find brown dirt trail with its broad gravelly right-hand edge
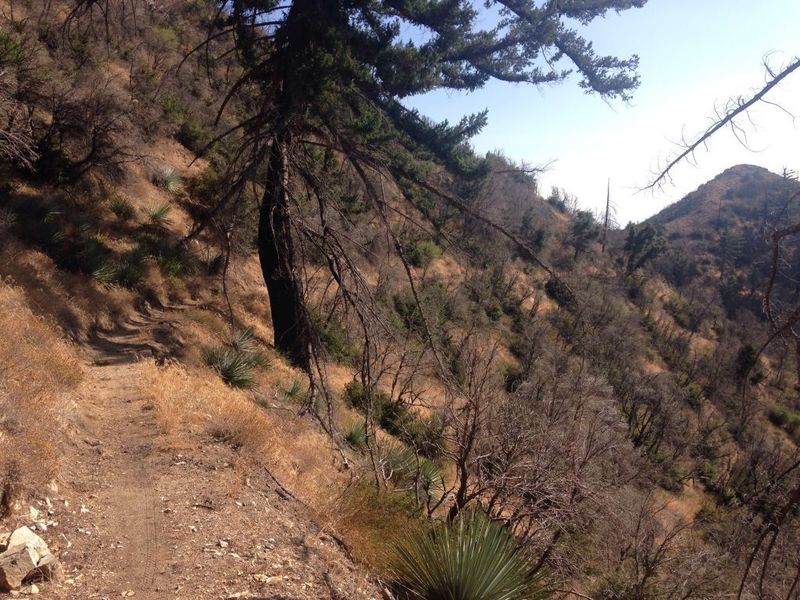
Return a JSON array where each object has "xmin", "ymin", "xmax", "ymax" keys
[{"xmin": 30, "ymin": 311, "xmax": 381, "ymax": 600}]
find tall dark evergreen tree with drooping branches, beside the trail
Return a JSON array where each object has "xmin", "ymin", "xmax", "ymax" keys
[{"xmin": 195, "ymin": 0, "xmax": 646, "ymax": 367}]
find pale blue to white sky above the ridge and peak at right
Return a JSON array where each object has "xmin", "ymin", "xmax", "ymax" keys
[{"xmin": 409, "ymin": 0, "xmax": 800, "ymax": 226}]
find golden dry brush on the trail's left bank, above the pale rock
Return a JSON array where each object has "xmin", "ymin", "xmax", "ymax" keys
[{"xmin": 0, "ymin": 283, "xmax": 81, "ymax": 517}]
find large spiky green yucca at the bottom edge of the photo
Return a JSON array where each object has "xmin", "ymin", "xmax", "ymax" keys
[{"xmin": 390, "ymin": 510, "xmax": 549, "ymax": 600}]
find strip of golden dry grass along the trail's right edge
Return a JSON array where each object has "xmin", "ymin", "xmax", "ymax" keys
[{"xmin": 142, "ymin": 361, "xmax": 428, "ymax": 571}]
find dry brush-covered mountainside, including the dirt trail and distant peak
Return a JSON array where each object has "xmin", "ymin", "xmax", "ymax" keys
[{"xmin": 0, "ymin": 0, "xmax": 800, "ymax": 600}]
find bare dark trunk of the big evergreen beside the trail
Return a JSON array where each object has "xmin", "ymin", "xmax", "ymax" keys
[{"xmin": 258, "ymin": 138, "xmax": 311, "ymax": 370}]
